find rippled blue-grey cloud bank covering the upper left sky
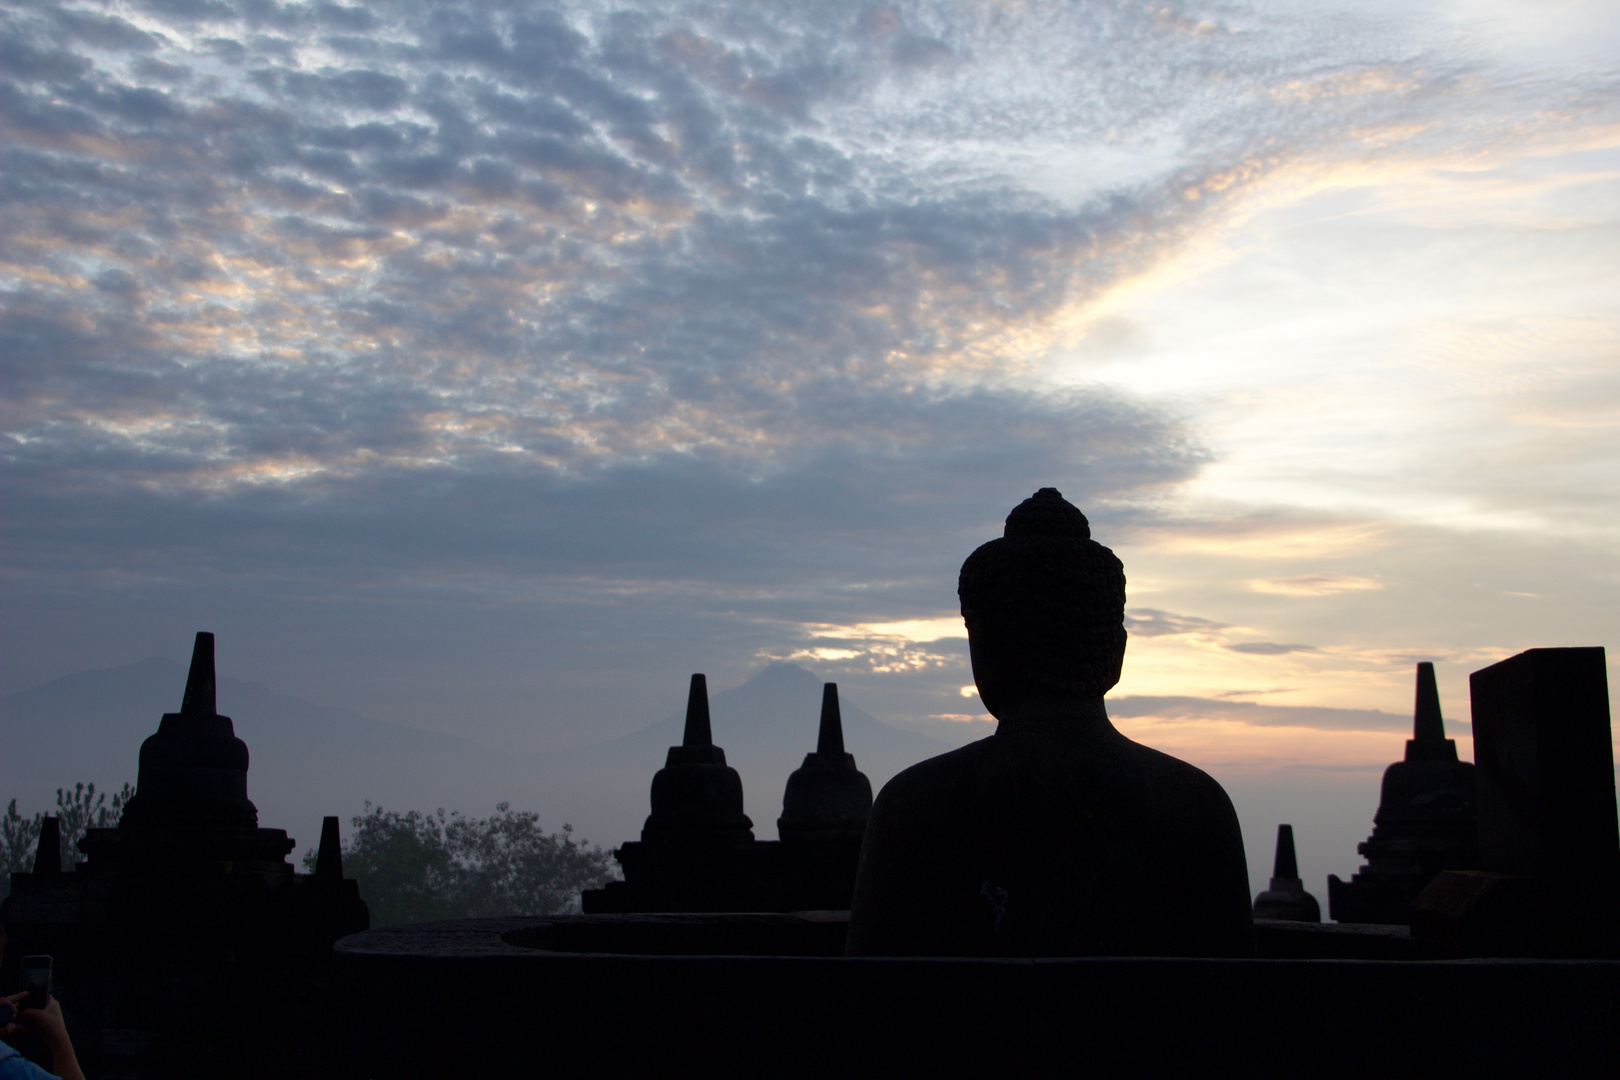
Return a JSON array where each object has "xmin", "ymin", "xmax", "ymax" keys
[{"xmin": 0, "ymin": 0, "xmax": 1496, "ymax": 621}]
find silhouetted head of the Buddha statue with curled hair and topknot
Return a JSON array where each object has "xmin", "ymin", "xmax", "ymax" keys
[{"xmin": 956, "ymin": 487, "xmax": 1126, "ymax": 708}]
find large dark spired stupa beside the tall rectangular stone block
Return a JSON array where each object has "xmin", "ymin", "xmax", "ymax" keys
[{"xmin": 1327, "ymin": 661, "xmax": 1479, "ymax": 925}]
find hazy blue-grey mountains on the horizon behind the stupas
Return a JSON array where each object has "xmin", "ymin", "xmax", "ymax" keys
[{"xmin": 0, "ymin": 657, "xmax": 949, "ymax": 852}]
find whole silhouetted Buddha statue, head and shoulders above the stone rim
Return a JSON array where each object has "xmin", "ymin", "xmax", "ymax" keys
[{"xmin": 847, "ymin": 487, "xmax": 1254, "ymax": 957}]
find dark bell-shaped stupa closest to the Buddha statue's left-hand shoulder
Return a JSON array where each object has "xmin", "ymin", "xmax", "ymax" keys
[{"xmin": 776, "ymin": 683, "xmax": 872, "ymax": 910}]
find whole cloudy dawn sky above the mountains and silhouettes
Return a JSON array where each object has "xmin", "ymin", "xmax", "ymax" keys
[{"xmin": 0, "ymin": 0, "xmax": 1620, "ymax": 873}]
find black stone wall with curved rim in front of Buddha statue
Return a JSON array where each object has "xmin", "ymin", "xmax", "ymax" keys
[{"xmin": 334, "ymin": 916, "xmax": 1620, "ymax": 1078}]
